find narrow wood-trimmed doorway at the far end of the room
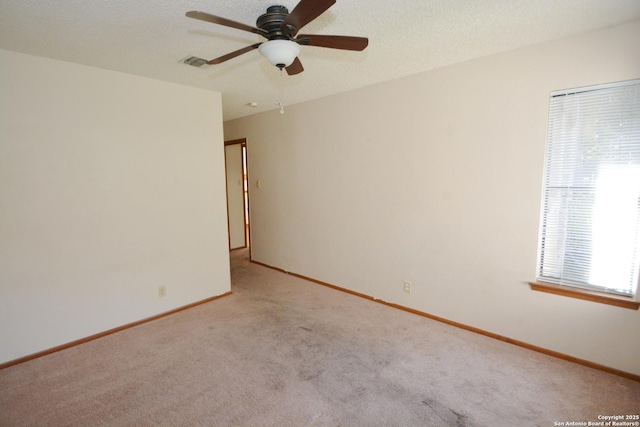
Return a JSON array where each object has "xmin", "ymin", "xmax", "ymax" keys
[{"xmin": 224, "ymin": 138, "xmax": 251, "ymax": 250}]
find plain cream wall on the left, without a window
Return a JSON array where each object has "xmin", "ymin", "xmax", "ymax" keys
[{"xmin": 0, "ymin": 51, "xmax": 230, "ymax": 362}]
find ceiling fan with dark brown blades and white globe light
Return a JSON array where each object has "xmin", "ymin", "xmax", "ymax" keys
[{"xmin": 187, "ymin": 0, "xmax": 369, "ymax": 75}]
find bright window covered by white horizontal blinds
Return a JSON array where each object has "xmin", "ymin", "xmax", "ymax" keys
[{"xmin": 538, "ymin": 80, "xmax": 640, "ymax": 296}]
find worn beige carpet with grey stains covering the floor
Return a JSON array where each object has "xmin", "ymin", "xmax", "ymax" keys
[{"xmin": 0, "ymin": 251, "xmax": 640, "ymax": 426}]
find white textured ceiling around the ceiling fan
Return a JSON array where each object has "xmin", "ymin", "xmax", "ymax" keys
[{"xmin": 0, "ymin": 0, "xmax": 640, "ymax": 120}]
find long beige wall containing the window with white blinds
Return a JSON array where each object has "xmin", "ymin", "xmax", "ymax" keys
[{"xmin": 225, "ymin": 22, "xmax": 640, "ymax": 374}]
